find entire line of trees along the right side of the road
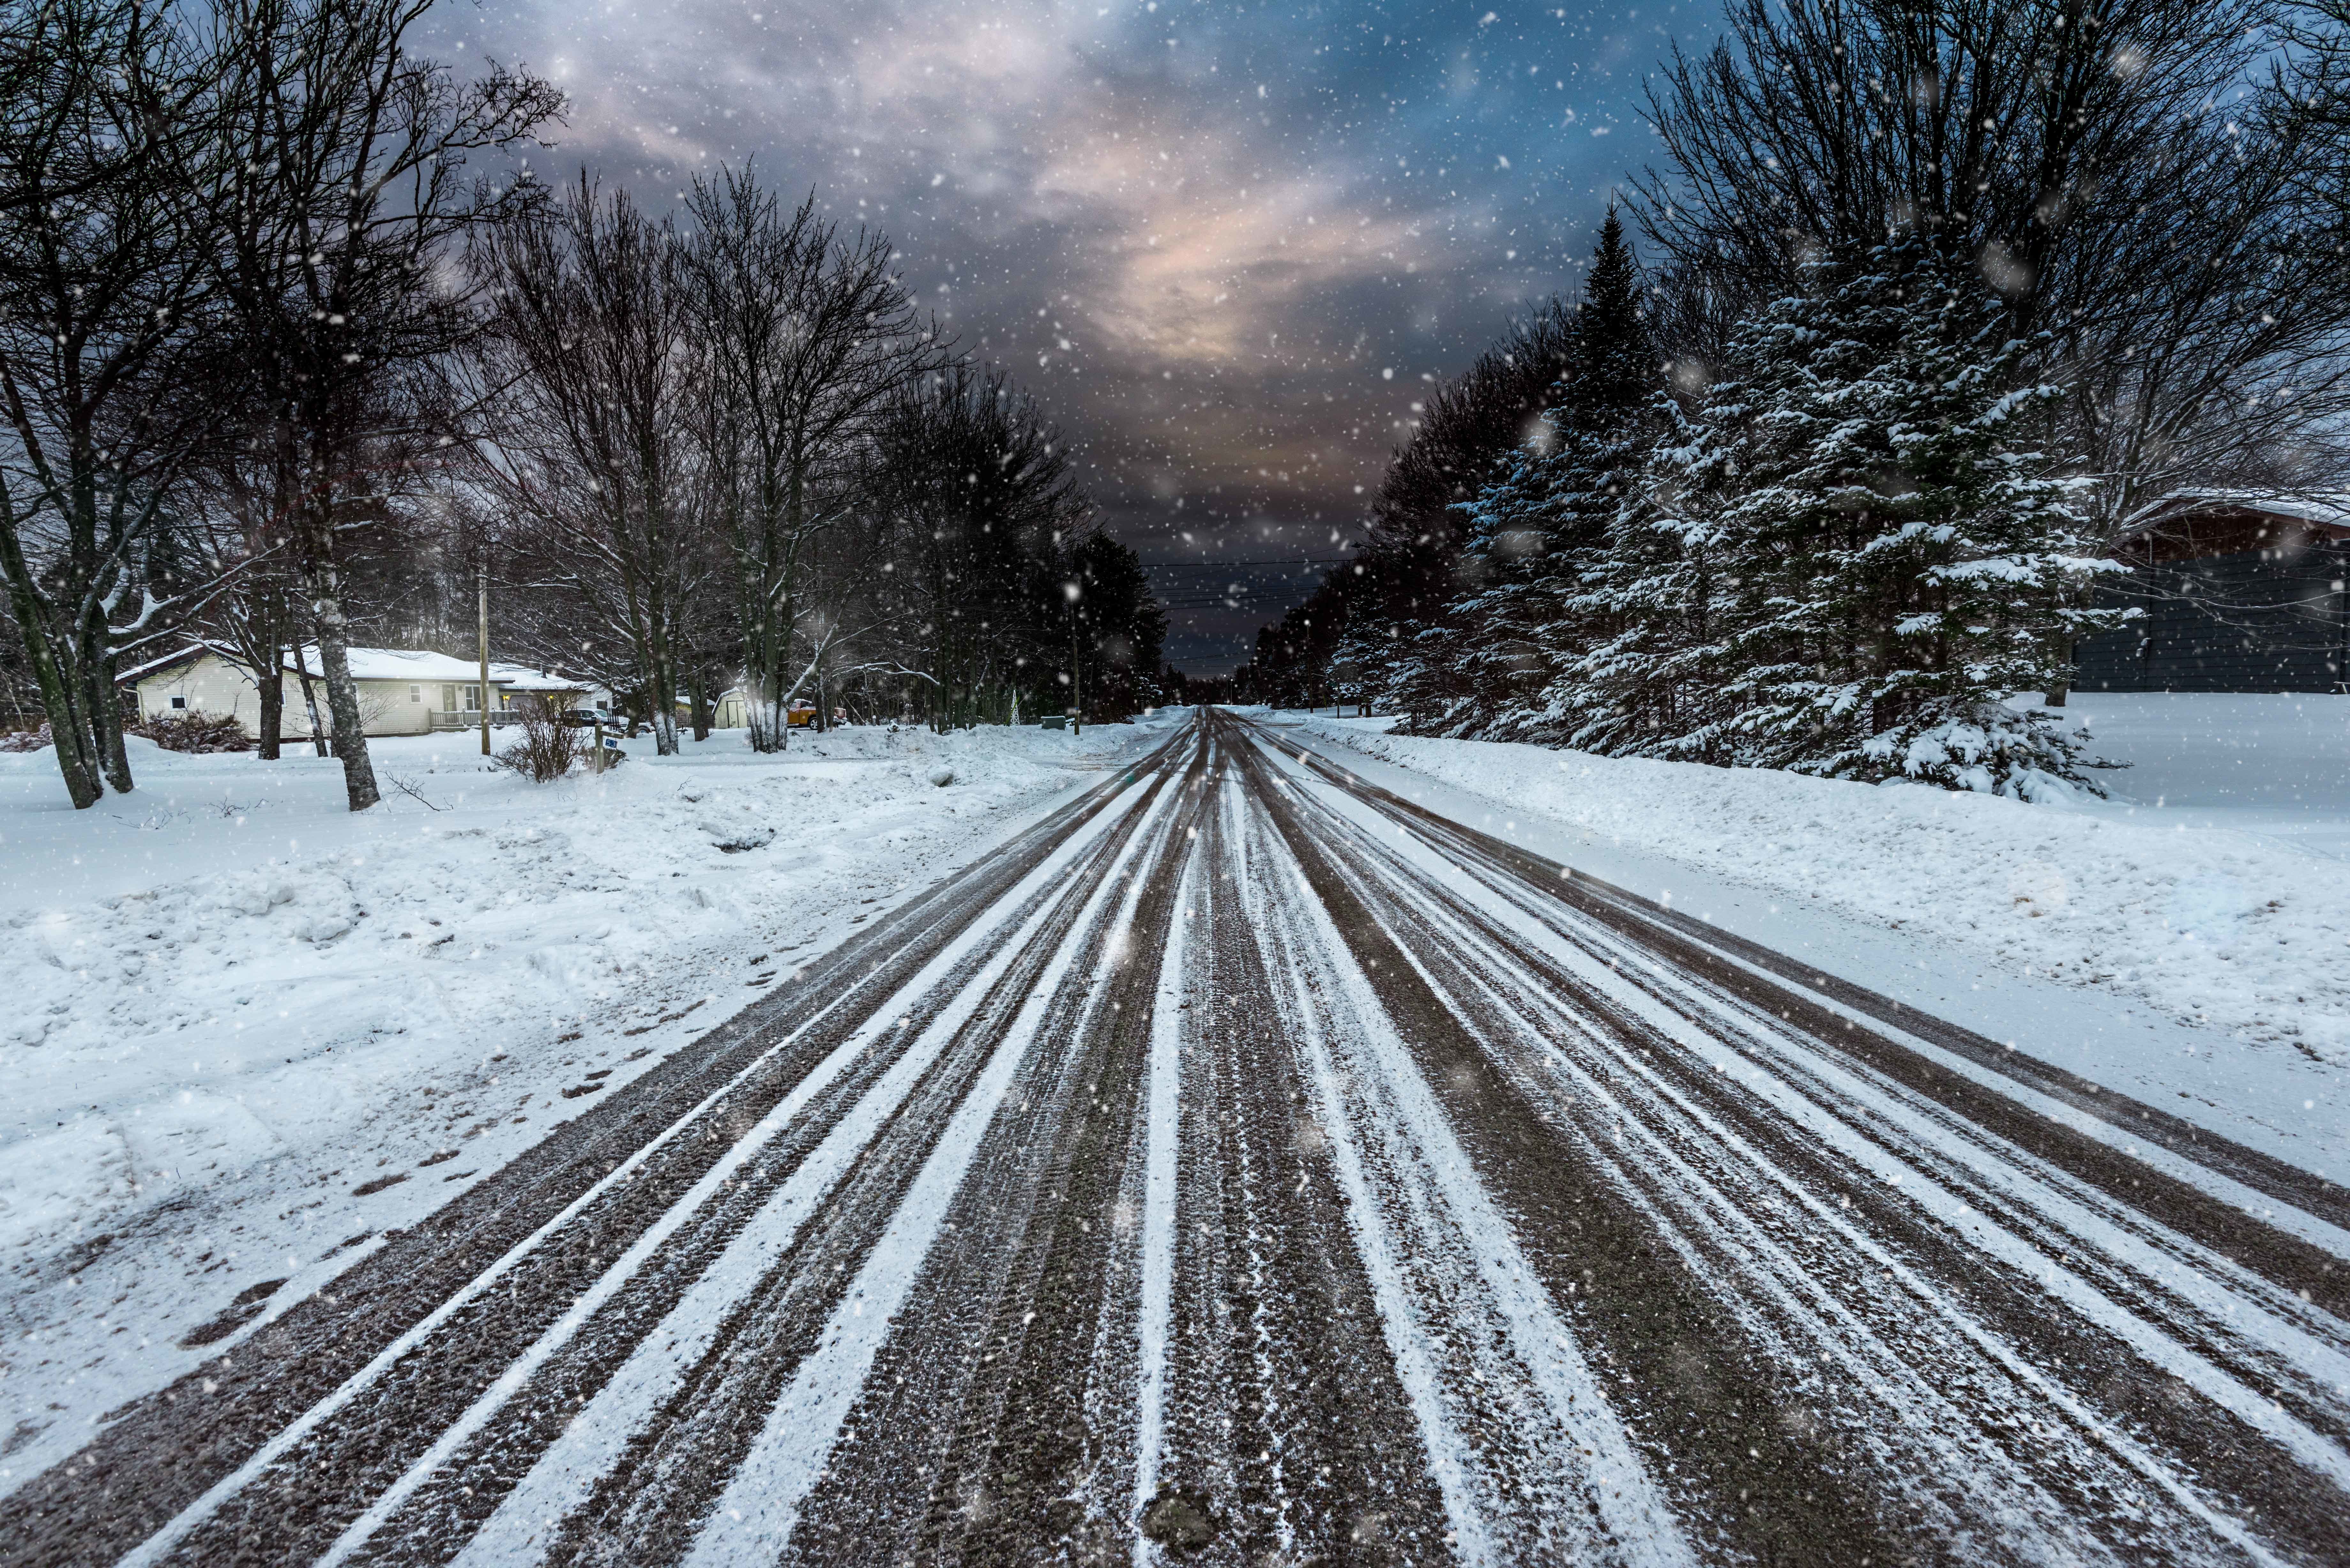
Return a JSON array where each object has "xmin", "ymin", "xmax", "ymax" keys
[{"xmin": 1243, "ymin": 0, "xmax": 2350, "ymax": 795}]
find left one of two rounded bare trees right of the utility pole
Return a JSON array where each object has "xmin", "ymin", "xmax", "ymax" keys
[{"xmin": 472, "ymin": 174, "xmax": 705, "ymax": 755}]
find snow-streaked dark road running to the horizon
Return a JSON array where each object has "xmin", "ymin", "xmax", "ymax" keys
[{"xmin": 0, "ymin": 715, "xmax": 2350, "ymax": 1566}]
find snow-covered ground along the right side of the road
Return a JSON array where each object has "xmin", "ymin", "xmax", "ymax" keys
[{"xmin": 1307, "ymin": 693, "xmax": 2350, "ymax": 1079}]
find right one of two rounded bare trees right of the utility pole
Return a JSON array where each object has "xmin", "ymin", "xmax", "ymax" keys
[{"xmin": 686, "ymin": 169, "xmax": 938, "ymax": 750}]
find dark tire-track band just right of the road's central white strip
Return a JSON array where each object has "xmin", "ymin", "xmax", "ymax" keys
[{"xmin": 1135, "ymin": 752, "xmax": 1448, "ymax": 1566}]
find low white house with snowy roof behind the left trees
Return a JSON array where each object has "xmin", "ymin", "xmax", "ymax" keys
[{"xmin": 120, "ymin": 642, "xmax": 611, "ymax": 741}]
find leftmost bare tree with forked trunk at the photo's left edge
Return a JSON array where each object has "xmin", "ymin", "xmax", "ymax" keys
[{"xmin": 0, "ymin": 0, "xmax": 214, "ymax": 809}]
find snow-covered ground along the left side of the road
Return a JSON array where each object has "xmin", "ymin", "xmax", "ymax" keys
[{"xmin": 0, "ymin": 715, "xmax": 1175, "ymax": 1490}]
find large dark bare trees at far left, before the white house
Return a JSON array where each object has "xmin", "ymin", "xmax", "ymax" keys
[{"xmin": 0, "ymin": 0, "xmax": 559, "ymax": 806}]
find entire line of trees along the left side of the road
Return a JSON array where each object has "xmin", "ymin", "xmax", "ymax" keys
[{"xmin": 0, "ymin": 0, "xmax": 1163, "ymax": 809}]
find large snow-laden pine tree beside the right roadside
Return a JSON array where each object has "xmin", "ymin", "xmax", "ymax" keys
[{"xmin": 1577, "ymin": 237, "xmax": 2124, "ymax": 799}]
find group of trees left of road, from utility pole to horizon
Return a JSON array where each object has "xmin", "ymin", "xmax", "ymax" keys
[{"xmin": 456, "ymin": 172, "xmax": 1166, "ymax": 750}]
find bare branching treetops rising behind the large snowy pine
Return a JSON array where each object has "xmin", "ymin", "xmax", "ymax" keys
[{"xmin": 1640, "ymin": 0, "xmax": 2350, "ymax": 531}]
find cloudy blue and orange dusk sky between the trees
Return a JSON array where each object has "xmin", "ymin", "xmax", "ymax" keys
[{"xmin": 425, "ymin": 0, "xmax": 1716, "ymax": 672}]
